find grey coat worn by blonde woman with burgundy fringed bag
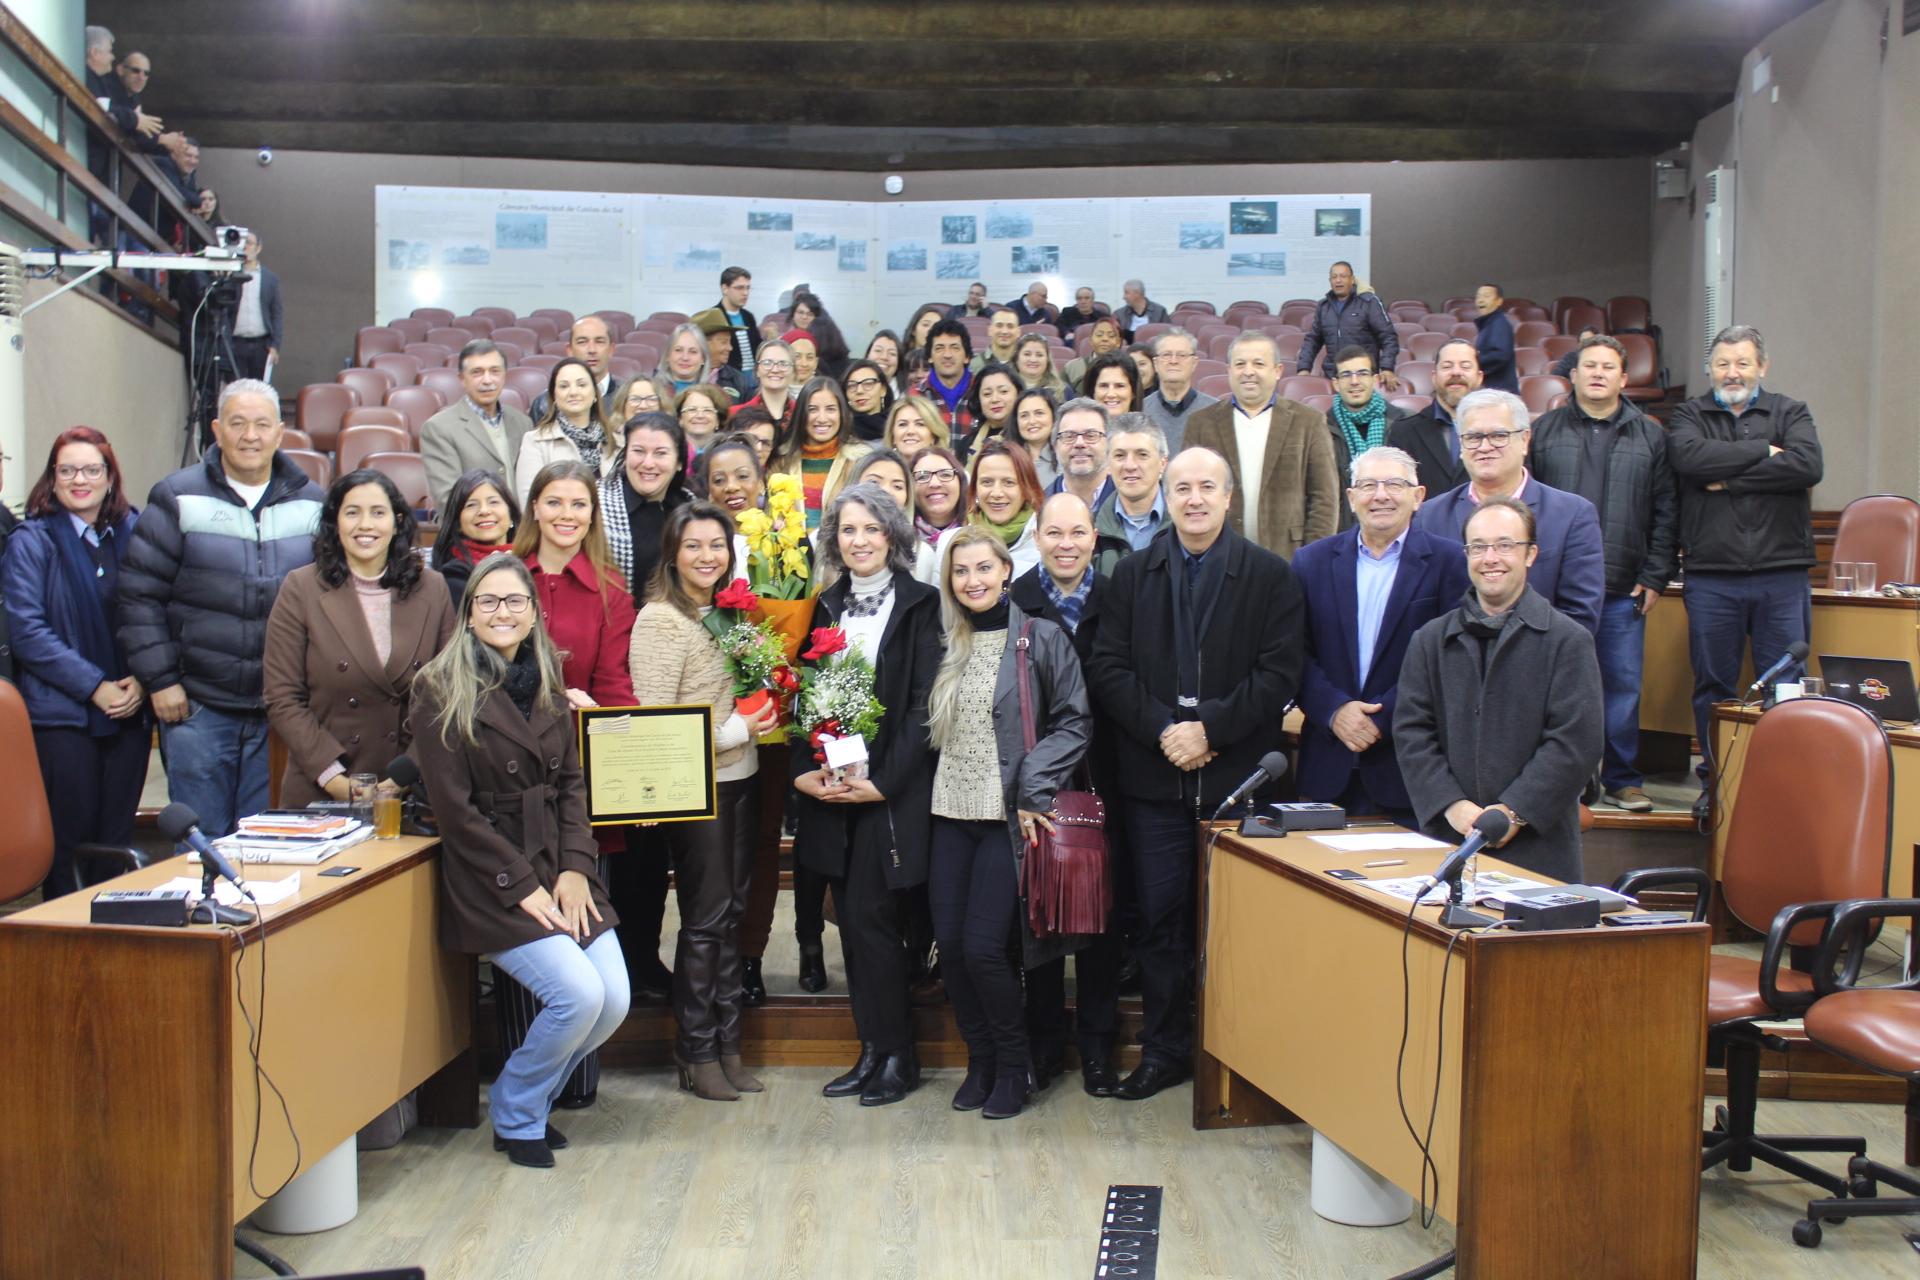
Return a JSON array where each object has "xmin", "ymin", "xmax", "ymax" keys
[{"xmin": 993, "ymin": 603, "xmax": 1092, "ymax": 969}]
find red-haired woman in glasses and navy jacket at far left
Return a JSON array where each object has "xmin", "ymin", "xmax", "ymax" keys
[{"xmin": 0, "ymin": 426, "xmax": 150, "ymax": 898}]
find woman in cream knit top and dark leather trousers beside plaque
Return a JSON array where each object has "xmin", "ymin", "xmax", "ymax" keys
[{"xmin": 630, "ymin": 501, "xmax": 780, "ymax": 1102}]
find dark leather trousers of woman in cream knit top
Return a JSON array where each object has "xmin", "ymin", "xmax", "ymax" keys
[{"xmin": 668, "ymin": 777, "xmax": 760, "ymax": 1063}]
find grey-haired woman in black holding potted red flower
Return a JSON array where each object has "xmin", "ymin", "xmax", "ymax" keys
[{"xmin": 789, "ymin": 484, "xmax": 941, "ymax": 1107}]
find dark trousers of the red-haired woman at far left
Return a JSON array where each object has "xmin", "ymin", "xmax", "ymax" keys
[{"xmin": 33, "ymin": 716, "xmax": 154, "ymax": 898}]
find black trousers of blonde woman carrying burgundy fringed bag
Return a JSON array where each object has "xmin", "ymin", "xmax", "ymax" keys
[{"xmin": 927, "ymin": 818, "xmax": 1031, "ymax": 1071}]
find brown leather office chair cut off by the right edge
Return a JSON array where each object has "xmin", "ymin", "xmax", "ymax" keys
[{"xmin": 1793, "ymin": 898, "xmax": 1920, "ymax": 1249}]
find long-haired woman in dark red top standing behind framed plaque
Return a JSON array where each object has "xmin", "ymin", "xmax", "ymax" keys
[{"xmin": 514, "ymin": 462, "xmax": 641, "ymax": 1107}]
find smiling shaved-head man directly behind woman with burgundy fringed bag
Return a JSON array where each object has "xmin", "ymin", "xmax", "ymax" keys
[{"xmin": 1010, "ymin": 493, "xmax": 1133, "ymax": 1098}]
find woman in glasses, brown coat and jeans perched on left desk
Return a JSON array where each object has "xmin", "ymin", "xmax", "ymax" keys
[{"xmin": 413, "ymin": 555, "xmax": 628, "ymax": 1169}]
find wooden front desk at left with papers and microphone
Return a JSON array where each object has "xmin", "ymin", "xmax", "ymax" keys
[{"xmin": 0, "ymin": 839, "xmax": 478, "ymax": 1280}]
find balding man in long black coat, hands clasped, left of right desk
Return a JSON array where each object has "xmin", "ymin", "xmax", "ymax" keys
[{"xmin": 1087, "ymin": 449, "xmax": 1306, "ymax": 1100}]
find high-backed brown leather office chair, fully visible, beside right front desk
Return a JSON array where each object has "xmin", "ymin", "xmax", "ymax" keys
[{"xmin": 1615, "ymin": 699, "xmax": 1893, "ymax": 1196}]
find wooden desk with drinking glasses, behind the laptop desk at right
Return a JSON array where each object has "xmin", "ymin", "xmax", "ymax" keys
[{"xmin": 1640, "ymin": 587, "xmax": 1920, "ymax": 737}]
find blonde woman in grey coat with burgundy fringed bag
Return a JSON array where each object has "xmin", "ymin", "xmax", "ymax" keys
[{"xmin": 927, "ymin": 528, "xmax": 1092, "ymax": 1121}]
